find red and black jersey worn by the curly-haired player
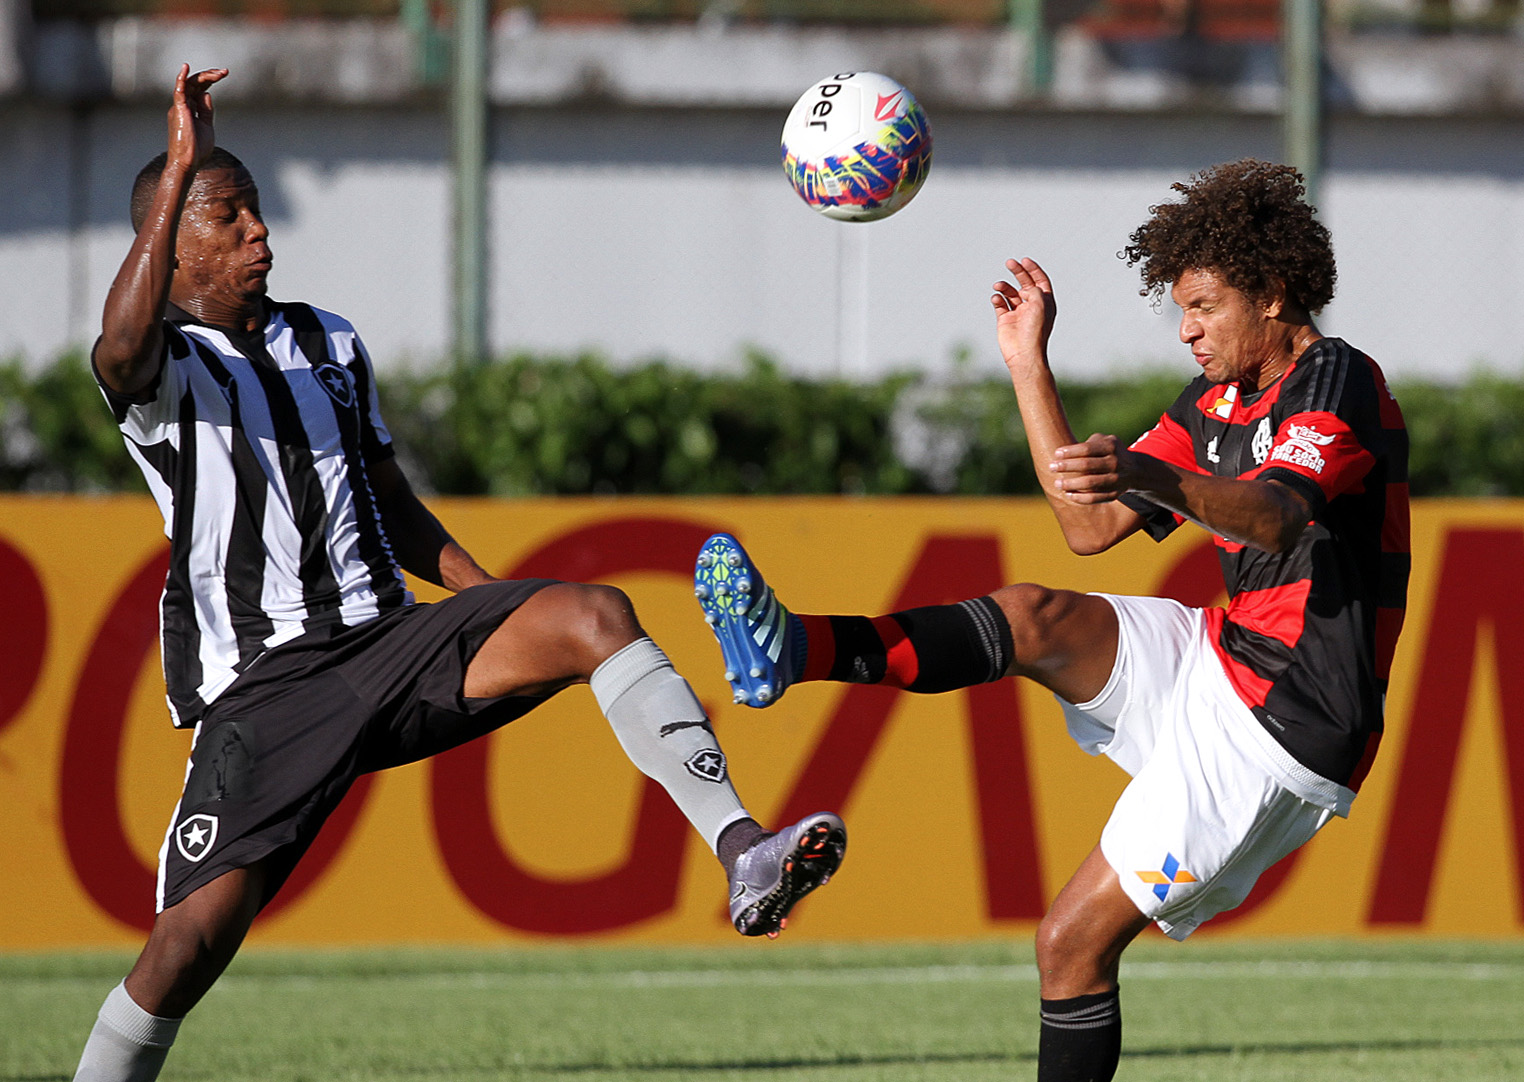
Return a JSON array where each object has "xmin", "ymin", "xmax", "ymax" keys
[{"xmin": 1123, "ymin": 338, "xmax": 1410, "ymax": 789}]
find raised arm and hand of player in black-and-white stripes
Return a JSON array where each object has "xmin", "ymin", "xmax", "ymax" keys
[{"xmin": 94, "ymin": 64, "xmax": 227, "ymax": 395}]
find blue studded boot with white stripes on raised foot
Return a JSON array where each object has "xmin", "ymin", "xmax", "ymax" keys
[{"xmin": 693, "ymin": 533, "xmax": 805, "ymax": 707}]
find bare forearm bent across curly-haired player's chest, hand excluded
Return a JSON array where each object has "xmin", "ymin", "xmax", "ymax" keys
[{"xmin": 1129, "ymin": 456, "xmax": 1311, "ymax": 553}]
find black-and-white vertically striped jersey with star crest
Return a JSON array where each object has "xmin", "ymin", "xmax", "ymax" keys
[{"xmin": 102, "ymin": 302, "xmax": 413, "ymax": 728}]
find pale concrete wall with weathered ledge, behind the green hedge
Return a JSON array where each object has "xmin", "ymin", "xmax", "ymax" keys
[{"xmin": 0, "ymin": 19, "xmax": 1524, "ymax": 376}]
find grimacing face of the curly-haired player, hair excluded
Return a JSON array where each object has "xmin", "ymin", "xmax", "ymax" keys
[{"xmin": 1169, "ymin": 270, "xmax": 1283, "ymax": 390}]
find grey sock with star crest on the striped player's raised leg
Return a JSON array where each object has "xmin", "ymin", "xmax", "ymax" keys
[{"xmin": 588, "ymin": 639, "xmax": 747, "ymax": 849}]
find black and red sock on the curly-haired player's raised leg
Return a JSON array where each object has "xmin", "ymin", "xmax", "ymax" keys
[{"xmin": 796, "ymin": 597, "xmax": 1012, "ymax": 695}]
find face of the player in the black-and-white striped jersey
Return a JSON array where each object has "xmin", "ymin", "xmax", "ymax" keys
[{"xmin": 175, "ymin": 169, "xmax": 273, "ymax": 308}]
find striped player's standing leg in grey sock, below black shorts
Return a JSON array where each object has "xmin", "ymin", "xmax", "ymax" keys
[{"xmin": 75, "ymin": 864, "xmax": 265, "ymax": 1082}]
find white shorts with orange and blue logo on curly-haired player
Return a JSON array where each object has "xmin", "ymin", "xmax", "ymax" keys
[{"xmin": 1059, "ymin": 594, "xmax": 1355, "ymax": 939}]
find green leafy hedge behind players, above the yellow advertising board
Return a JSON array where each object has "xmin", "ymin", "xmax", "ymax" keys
[{"xmin": 0, "ymin": 354, "xmax": 1524, "ymax": 495}]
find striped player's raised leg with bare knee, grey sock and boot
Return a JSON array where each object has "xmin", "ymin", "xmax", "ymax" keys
[{"xmin": 465, "ymin": 582, "xmax": 846, "ymax": 936}]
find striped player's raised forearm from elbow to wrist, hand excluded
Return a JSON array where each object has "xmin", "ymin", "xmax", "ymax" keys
[{"xmin": 94, "ymin": 165, "xmax": 194, "ymax": 393}]
